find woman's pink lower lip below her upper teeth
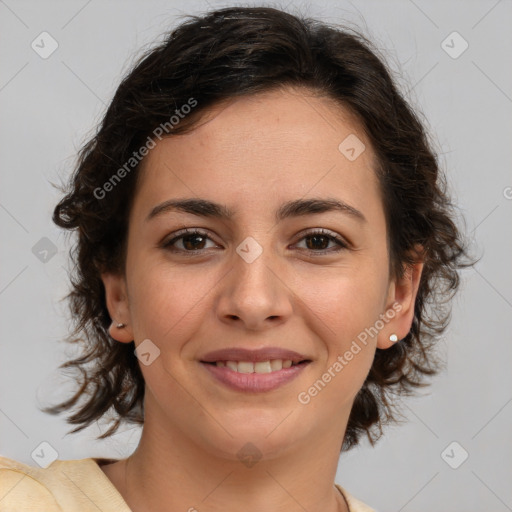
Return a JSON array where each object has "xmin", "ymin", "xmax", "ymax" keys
[{"xmin": 201, "ymin": 363, "xmax": 309, "ymax": 393}]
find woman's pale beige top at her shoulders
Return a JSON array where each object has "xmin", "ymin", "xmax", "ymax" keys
[{"xmin": 0, "ymin": 456, "xmax": 375, "ymax": 512}]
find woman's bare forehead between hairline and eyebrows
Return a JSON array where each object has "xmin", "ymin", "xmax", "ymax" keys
[{"xmin": 137, "ymin": 88, "xmax": 379, "ymax": 222}]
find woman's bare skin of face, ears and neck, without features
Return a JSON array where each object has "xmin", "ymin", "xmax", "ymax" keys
[{"xmin": 102, "ymin": 88, "xmax": 423, "ymax": 512}]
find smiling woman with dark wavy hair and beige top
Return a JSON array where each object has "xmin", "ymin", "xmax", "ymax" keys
[{"xmin": 0, "ymin": 7, "xmax": 469, "ymax": 512}]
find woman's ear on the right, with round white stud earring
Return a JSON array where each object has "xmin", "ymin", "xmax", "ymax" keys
[{"xmin": 377, "ymin": 246, "xmax": 424, "ymax": 349}]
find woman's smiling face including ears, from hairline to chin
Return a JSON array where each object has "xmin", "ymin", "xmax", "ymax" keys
[{"xmin": 103, "ymin": 89, "xmax": 421, "ymax": 460}]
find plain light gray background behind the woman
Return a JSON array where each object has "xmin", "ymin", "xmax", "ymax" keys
[{"xmin": 0, "ymin": 0, "xmax": 512, "ymax": 512}]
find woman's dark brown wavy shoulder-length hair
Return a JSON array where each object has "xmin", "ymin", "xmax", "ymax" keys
[{"xmin": 43, "ymin": 7, "xmax": 472, "ymax": 450}]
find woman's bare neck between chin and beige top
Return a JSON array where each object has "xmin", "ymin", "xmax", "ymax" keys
[{"xmin": 104, "ymin": 394, "xmax": 348, "ymax": 512}]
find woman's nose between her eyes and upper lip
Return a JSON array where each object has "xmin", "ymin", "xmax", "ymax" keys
[{"xmin": 217, "ymin": 240, "xmax": 294, "ymax": 331}]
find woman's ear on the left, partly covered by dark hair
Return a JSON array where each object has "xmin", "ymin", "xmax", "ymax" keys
[{"xmin": 101, "ymin": 273, "xmax": 133, "ymax": 343}]
